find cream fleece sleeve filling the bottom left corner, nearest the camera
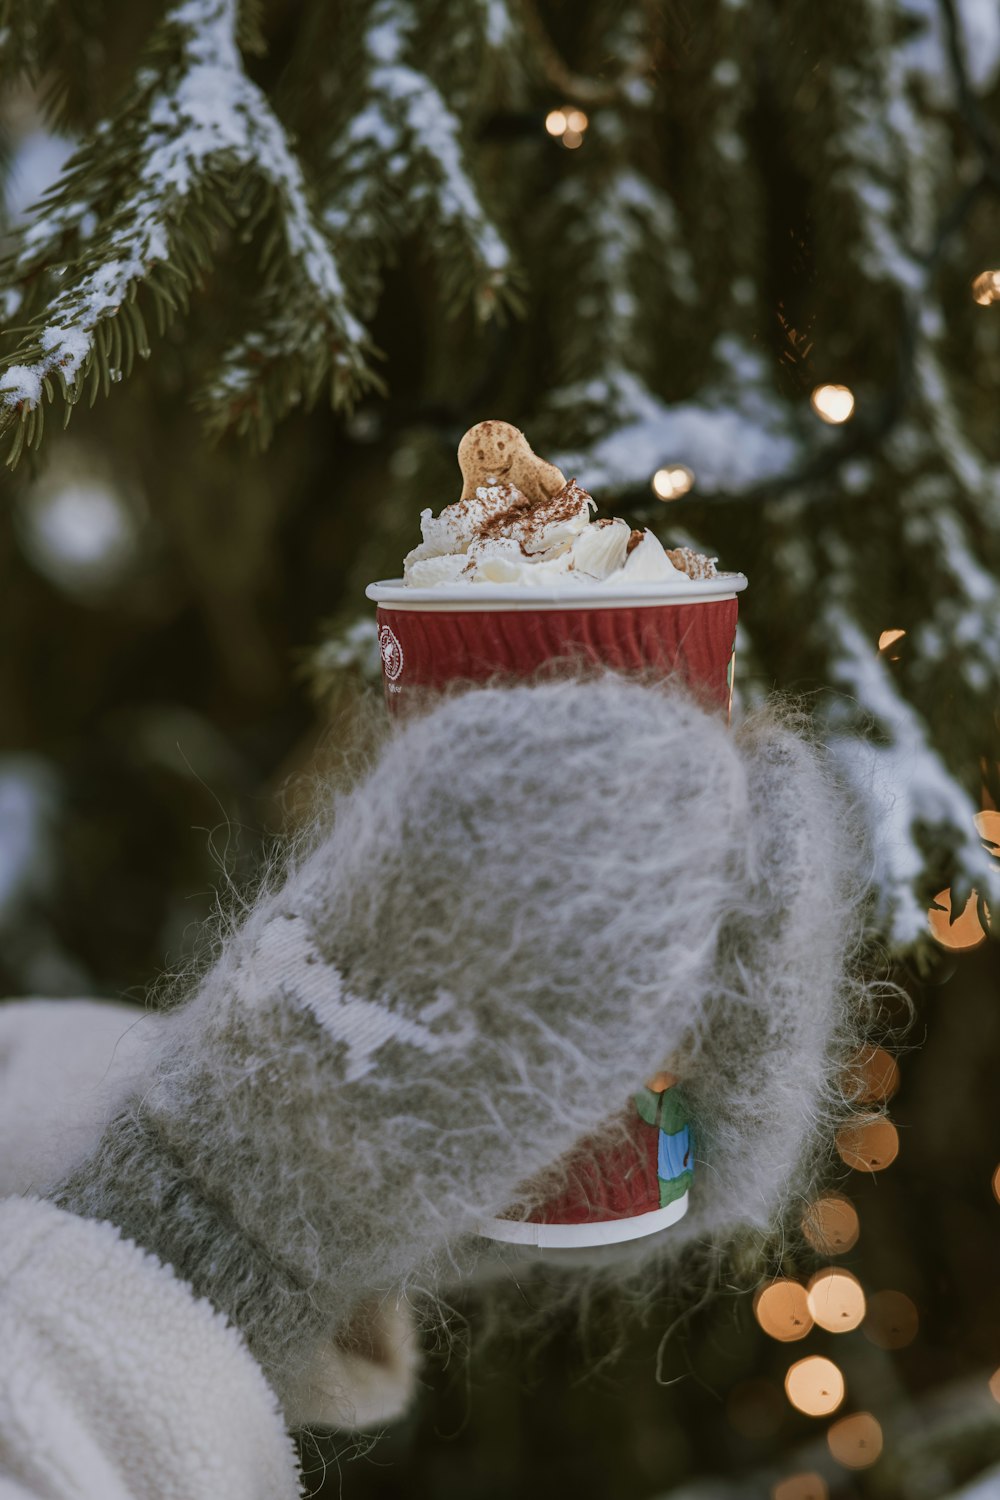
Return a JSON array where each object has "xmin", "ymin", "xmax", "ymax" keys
[{"xmin": 0, "ymin": 1199, "xmax": 301, "ymax": 1500}]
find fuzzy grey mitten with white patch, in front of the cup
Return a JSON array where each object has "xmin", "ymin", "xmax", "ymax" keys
[{"xmin": 52, "ymin": 677, "xmax": 863, "ymax": 1394}]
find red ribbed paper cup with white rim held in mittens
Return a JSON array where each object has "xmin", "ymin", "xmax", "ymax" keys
[{"xmin": 366, "ymin": 573, "xmax": 747, "ymax": 1250}]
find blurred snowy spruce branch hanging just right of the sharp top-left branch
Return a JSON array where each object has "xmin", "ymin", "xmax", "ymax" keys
[{"xmin": 324, "ymin": 0, "xmax": 511, "ymax": 317}]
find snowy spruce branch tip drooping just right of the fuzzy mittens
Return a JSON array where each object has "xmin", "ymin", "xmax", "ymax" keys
[{"xmin": 826, "ymin": 606, "xmax": 997, "ymax": 948}]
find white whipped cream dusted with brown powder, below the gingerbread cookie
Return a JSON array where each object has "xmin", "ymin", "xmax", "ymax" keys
[{"xmin": 403, "ymin": 479, "xmax": 715, "ymax": 588}]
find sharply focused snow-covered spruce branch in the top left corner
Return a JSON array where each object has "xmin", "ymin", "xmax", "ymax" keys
[{"xmin": 0, "ymin": 0, "xmax": 366, "ymax": 458}]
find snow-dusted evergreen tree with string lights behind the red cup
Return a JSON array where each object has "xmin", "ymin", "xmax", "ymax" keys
[{"xmin": 0, "ymin": 0, "xmax": 1000, "ymax": 947}]
